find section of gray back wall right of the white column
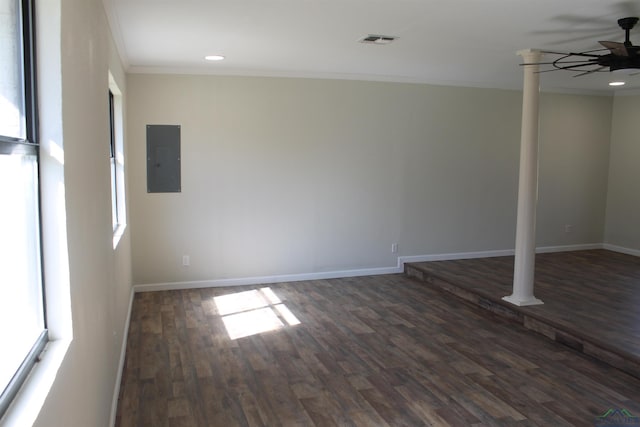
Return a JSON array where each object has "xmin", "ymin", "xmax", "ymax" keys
[{"xmin": 537, "ymin": 94, "xmax": 613, "ymax": 246}]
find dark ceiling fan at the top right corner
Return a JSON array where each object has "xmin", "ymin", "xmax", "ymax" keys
[{"xmin": 520, "ymin": 17, "xmax": 640, "ymax": 77}]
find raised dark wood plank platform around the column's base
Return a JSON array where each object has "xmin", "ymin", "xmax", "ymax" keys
[{"xmin": 405, "ymin": 250, "xmax": 640, "ymax": 378}]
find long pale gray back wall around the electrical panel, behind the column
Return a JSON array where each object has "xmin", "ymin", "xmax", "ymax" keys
[{"xmin": 128, "ymin": 74, "xmax": 612, "ymax": 284}]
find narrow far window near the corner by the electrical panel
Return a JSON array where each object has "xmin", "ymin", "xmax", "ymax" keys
[{"xmin": 109, "ymin": 73, "xmax": 127, "ymax": 249}]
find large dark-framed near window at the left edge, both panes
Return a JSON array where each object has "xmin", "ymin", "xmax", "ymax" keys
[{"xmin": 0, "ymin": 0, "xmax": 48, "ymax": 416}]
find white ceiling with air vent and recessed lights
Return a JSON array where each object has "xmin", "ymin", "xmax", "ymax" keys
[{"xmin": 103, "ymin": 0, "xmax": 640, "ymax": 92}]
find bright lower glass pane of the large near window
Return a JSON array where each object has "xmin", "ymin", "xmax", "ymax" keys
[{"xmin": 0, "ymin": 154, "xmax": 44, "ymax": 390}]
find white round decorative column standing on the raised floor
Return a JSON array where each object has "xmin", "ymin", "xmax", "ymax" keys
[{"xmin": 502, "ymin": 49, "xmax": 543, "ymax": 306}]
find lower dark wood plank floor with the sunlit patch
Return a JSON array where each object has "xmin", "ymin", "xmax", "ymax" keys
[{"xmin": 116, "ymin": 275, "xmax": 640, "ymax": 427}]
